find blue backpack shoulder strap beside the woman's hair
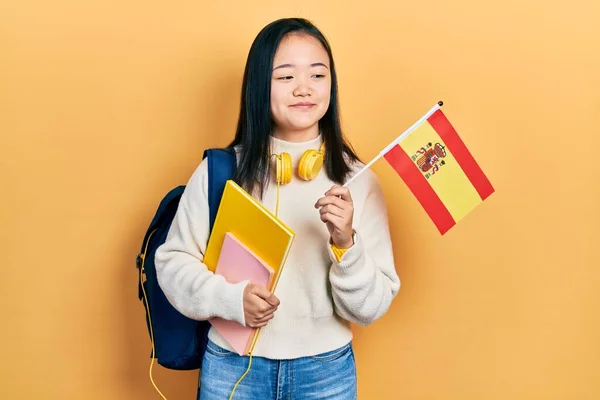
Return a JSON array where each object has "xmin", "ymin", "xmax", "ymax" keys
[{"xmin": 202, "ymin": 147, "xmax": 237, "ymax": 231}]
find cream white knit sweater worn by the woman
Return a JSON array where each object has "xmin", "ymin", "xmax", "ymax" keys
[{"xmin": 155, "ymin": 136, "xmax": 400, "ymax": 359}]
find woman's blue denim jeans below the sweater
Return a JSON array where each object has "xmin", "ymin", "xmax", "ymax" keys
[{"xmin": 198, "ymin": 341, "xmax": 357, "ymax": 400}]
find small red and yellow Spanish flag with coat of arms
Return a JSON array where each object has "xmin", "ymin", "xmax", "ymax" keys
[{"xmin": 380, "ymin": 102, "xmax": 494, "ymax": 235}]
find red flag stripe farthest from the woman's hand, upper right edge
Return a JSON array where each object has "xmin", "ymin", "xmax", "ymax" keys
[{"xmin": 427, "ymin": 110, "xmax": 494, "ymax": 200}]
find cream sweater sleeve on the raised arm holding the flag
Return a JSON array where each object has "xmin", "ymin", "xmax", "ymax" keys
[{"xmin": 327, "ymin": 174, "xmax": 400, "ymax": 326}]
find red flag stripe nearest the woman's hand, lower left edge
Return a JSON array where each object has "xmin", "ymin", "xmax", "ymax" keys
[{"xmin": 384, "ymin": 145, "xmax": 456, "ymax": 235}]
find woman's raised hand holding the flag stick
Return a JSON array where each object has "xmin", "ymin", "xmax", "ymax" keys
[{"xmin": 315, "ymin": 185, "xmax": 354, "ymax": 249}]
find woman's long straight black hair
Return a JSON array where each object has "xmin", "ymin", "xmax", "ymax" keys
[{"xmin": 229, "ymin": 18, "xmax": 359, "ymax": 197}]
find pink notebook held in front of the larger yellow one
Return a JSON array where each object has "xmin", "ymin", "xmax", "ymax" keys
[{"xmin": 209, "ymin": 232, "xmax": 274, "ymax": 355}]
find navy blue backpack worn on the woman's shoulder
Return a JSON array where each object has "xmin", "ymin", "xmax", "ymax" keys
[{"xmin": 136, "ymin": 148, "xmax": 237, "ymax": 370}]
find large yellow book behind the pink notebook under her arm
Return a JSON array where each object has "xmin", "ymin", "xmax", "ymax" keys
[{"xmin": 204, "ymin": 180, "xmax": 295, "ymax": 292}]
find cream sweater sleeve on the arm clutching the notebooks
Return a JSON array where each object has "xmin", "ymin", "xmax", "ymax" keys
[{"xmin": 155, "ymin": 160, "xmax": 248, "ymax": 325}]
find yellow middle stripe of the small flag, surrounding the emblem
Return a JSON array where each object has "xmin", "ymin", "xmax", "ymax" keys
[{"xmin": 399, "ymin": 121, "xmax": 482, "ymax": 222}]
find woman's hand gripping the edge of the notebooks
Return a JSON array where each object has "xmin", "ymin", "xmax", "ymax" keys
[{"xmin": 244, "ymin": 283, "xmax": 279, "ymax": 328}]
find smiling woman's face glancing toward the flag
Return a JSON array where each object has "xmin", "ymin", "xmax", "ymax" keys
[{"xmin": 271, "ymin": 34, "xmax": 331, "ymax": 140}]
